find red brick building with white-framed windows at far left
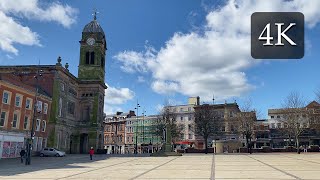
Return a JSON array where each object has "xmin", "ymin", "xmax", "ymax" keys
[{"xmin": 0, "ymin": 74, "xmax": 51, "ymax": 158}]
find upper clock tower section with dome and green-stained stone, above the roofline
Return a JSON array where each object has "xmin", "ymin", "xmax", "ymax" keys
[{"xmin": 78, "ymin": 13, "xmax": 107, "ymax": 83}]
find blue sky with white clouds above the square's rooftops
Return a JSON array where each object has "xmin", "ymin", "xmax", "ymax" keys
[{"xmin": 0, "ymin": 0, "xmax": 320, "ymax": 118}]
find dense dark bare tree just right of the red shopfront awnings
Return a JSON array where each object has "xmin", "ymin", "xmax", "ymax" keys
[{"xmin": 194, "ymin": 104, "xmax": 222, "ymax": 154}]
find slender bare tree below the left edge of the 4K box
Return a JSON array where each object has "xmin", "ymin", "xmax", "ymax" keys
[{"xmin": 236, "ymin": 99, "xmax": 257, "ymax": 154}]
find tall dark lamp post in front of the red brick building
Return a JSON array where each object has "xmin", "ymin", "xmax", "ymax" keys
[{"xmin": 25, "ymin": 69, "xmax": 43, "ymax": 165}]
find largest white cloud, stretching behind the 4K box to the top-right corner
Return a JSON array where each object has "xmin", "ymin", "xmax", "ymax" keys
[{"xmin": 115, "ymin": 0, "xmax": 320, "ymax": 101}]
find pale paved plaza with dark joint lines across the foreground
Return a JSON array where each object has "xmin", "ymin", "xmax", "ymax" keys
[{"xmin": 0, "ymin": 153, "xmax": 320, "ymax": 180}]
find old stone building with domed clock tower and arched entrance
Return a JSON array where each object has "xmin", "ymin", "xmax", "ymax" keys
[{"xmin": 0, "ymin": 17, "xmax": 107, "ymax": 153}]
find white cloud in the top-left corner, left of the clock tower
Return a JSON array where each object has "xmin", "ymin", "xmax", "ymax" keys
[{"xmin": 0, "ymin": 0, "xmax": 77, "ymax": 55}]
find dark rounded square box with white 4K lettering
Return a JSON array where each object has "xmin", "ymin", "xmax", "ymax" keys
[{"xmin": 251, "ymin": 12, "xmax": 304, "ymax": 59}]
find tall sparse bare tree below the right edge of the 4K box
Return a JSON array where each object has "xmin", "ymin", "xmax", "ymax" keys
[{"xmin": 281, "ymin": 92, "xmax": 310, "ymax": 153}]
